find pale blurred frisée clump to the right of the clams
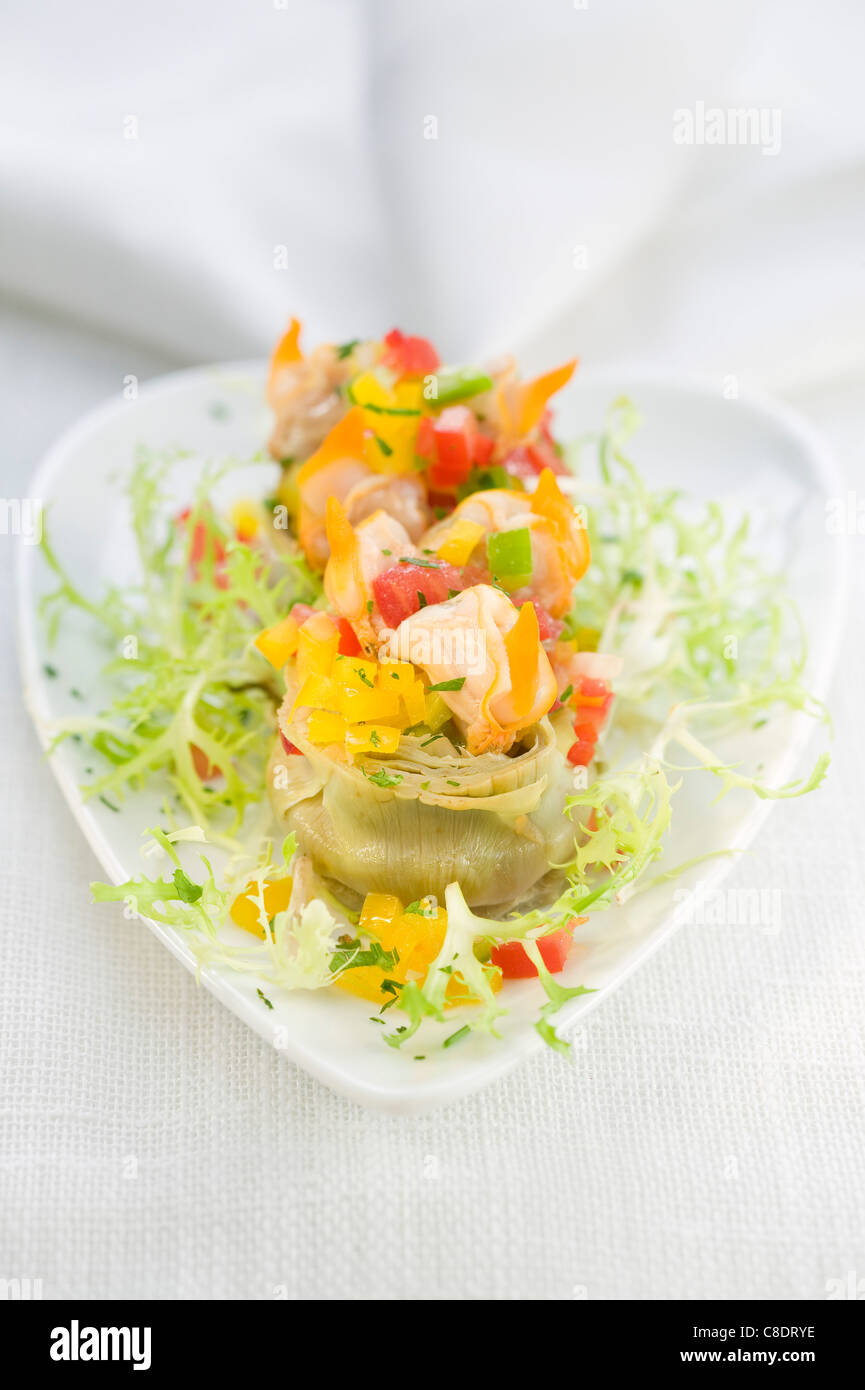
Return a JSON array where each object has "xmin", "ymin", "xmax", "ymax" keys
[{"xmin": 567, "ymin": 398, "xmax": 807, "ymax": 714}]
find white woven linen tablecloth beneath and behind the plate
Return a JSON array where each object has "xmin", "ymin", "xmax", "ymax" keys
[{"xmin": 0, "ymin": 0, "xmax": 865, "ymax": 1298}]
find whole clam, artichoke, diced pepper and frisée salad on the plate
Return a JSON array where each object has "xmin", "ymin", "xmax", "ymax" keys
[{"xmin": 43, "ymin": 320, "xmax": 827, "ymax": 1056}]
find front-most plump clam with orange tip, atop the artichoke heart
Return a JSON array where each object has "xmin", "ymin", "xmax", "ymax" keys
[{"xmin": 391, "ymin": 584, "xmax": 556, "ymax": 753}]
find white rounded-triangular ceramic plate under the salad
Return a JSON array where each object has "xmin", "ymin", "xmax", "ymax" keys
[{"xmin": 19, "ymin": 363, "xmax": 846, "ymax": 1113}]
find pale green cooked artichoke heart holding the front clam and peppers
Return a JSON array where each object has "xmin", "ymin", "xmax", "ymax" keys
[{"xmin": 268, "ymin": 694, "xmax": 584, "ymax": 908}]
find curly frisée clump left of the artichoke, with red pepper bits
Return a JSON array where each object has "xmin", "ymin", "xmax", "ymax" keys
[{"xmin": 43, "ymin": 452, "xmax": 320, "ymax": 848}]
